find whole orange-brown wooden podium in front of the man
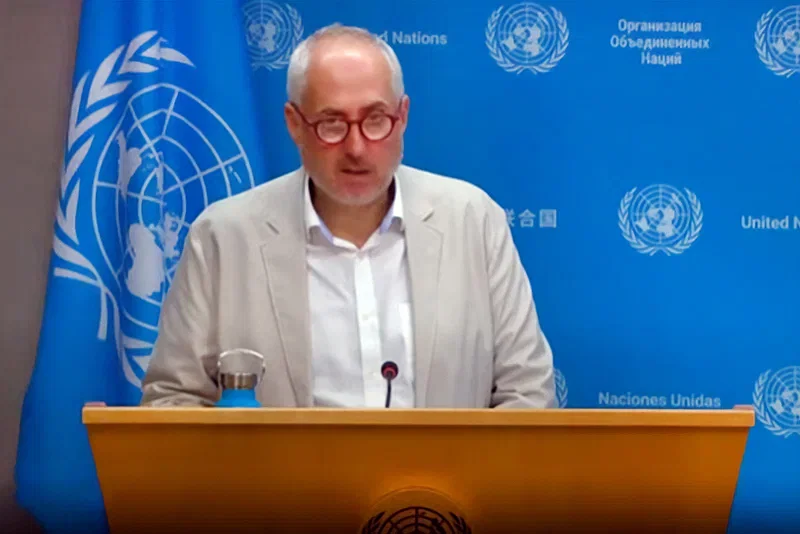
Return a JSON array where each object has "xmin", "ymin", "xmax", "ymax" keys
[{"xmin": 83, "ymin": 406, "xmax": 755, "ymax": 534}]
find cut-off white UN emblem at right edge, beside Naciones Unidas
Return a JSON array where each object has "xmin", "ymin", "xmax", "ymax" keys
[{"xmin": 753, "ymin": 365, "xmax": 800, "ymax": 437}]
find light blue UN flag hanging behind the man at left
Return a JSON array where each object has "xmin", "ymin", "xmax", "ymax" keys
[{"xmin": 16, "ymin": 0, "xmax": 266, "ymax": 532}]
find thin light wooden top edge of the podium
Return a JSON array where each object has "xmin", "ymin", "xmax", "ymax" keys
[{"xmin": 78, "ymin": 406, "xmax": 755, "ymax": 428}]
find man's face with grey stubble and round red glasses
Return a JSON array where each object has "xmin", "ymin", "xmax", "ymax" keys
[{"xmin": 285, "ymin": 38, "xmax": 408, "ymax": 206}]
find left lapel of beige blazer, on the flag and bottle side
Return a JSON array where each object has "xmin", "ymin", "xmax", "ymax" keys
[{"xmin": 261, "ymin": 171, "xmax": 312, "ymax": 406}]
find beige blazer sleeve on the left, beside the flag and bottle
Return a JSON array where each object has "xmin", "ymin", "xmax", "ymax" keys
[{"xmin": 141, "ymin": 226, "xmax": 218, "ymax": 406}]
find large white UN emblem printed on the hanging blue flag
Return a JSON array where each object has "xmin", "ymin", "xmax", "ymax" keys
[{"xmin": 53, "ymin": 31, "xmax": 254, "ymax": 387}]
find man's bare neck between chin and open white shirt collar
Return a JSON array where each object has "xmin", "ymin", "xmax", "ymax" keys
[{"xmin": 309, "ymin": 182, "xmax": 395, "ymax": 248}]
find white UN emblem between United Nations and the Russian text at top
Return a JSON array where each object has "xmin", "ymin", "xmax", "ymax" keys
[{"xmin": 486, "ymin": 2, "xmax": 569, "ymax": 74}]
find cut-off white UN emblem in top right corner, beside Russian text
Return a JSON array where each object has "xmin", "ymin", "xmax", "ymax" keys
[{"xmin": 755, "ymin": 5, "xmax": 800, "ymax": 78}]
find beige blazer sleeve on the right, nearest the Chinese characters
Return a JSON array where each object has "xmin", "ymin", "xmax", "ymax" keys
[{"xmin": 486, "ymin": 200, "xmax": 556, "ymax": 408}]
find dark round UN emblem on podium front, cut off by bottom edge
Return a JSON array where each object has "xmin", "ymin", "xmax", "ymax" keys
[{"xmin": 361, "ymin": 488, "xmax": 472, "ymax": 534}]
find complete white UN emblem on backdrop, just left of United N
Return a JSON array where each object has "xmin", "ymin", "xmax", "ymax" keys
[{"xmin": 618, "ymin": 184, "xmax": 703, "ymax": 256}]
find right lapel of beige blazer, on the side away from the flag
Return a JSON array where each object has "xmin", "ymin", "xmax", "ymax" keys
[{"xmin": 398, "ymin": 173, "xmax": 442, "ymax": 407}]
